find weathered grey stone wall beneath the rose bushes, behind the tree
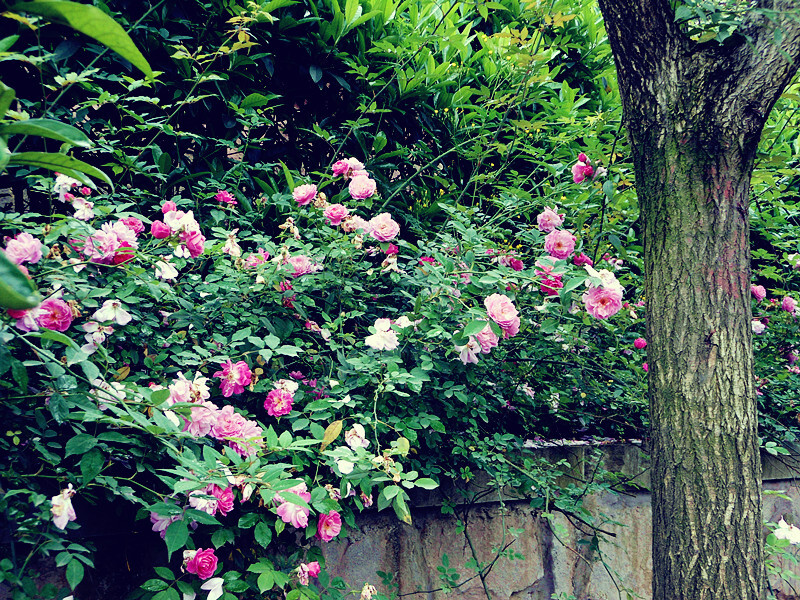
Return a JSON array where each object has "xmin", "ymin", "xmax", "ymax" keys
[{"xmin": 323, "ymin": 445, "xmax": 800, "ymax": 600}]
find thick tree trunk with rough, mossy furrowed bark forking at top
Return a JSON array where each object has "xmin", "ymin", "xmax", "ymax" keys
[{"xmin": 600, "ymin": 0, "xmax": 800, "ymax": 600}]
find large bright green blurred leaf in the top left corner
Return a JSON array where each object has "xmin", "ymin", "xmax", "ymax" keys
[{"xmin": 10, "ymin": 0, "xmax": 153, "ymax": 79}]
